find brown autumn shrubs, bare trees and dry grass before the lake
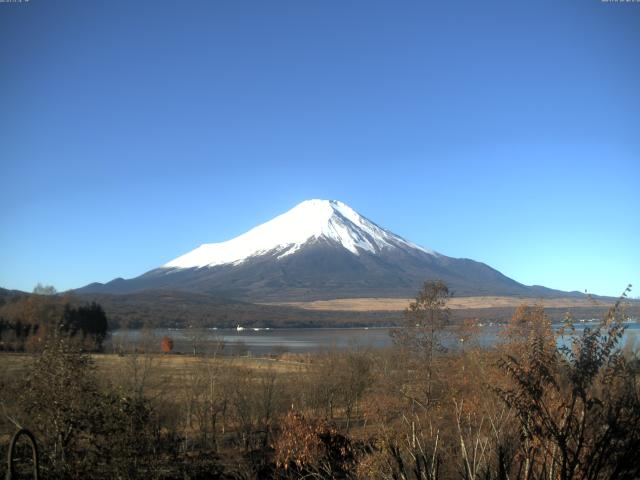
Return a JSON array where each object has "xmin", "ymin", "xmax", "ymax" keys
[{"xmin": 0, "ymin": 282, "xmax": 640, "ymax": 480}]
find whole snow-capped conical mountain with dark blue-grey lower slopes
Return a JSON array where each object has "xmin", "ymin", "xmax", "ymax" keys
[{"xmin": 76, "ymin": 200, "xmax": 568, "ymax": 301}]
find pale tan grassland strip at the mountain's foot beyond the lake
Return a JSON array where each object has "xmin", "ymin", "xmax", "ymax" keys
[{"xmin": 269, "ymin": 297, "xmax": 613, "ymax": 312}]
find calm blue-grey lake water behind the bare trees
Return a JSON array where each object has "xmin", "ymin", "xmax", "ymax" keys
[{"xmin": 107, "ymin": 321, "xmax": 640, "ymax": 355}]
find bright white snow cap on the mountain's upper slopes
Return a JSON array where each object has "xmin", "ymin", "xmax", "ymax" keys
[{"xmin": 162, "ymin": 200, "xmax": 438, "ymax": 269}]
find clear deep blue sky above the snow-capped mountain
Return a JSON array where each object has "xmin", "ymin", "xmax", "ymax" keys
[{"xmin": 0, "ymin": 0, "xmax": 640, "ymax": 296}]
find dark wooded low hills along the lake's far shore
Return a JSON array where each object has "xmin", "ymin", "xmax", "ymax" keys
[{"xmin": 0, "ymin": 288, "xmax": 640, "ymax": 329}]
